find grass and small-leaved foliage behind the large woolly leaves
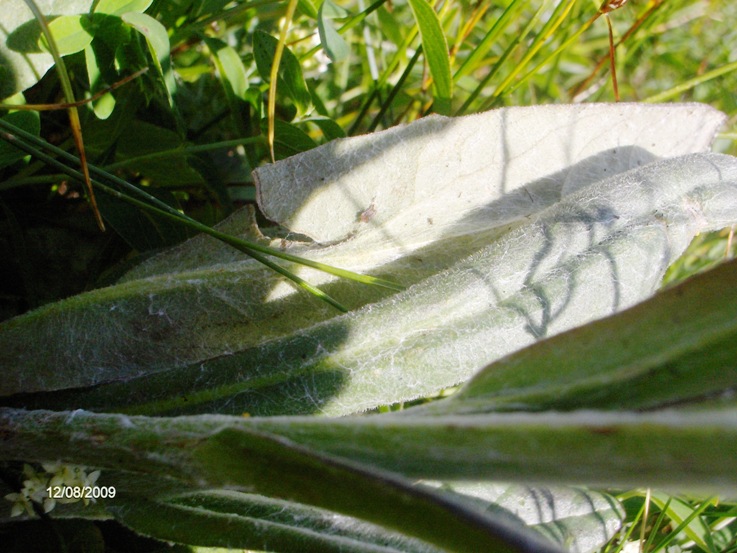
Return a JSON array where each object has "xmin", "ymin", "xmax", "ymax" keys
[{"xmin": 0, "ymin": 0, "xmax": 737, "ymax": 551}]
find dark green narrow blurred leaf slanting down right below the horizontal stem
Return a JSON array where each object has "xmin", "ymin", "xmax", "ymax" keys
[{"xmin": 193, "ymin": 429, "xmax": 558, "ymax": 553}]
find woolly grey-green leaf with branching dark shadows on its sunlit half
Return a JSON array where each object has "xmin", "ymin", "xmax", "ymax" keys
[{"xmin": 7, "ymin": 154, "xmax": 737, "ymax": 415}]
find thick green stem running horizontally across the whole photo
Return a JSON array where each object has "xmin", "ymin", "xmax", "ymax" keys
[{"xmin": 0, "ymin": 403, "xmax": 737, "ymax": 498}]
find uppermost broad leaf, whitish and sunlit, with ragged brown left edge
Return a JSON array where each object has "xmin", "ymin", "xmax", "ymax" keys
[{"xmin": 255, "ymin": 104, "xmax": 724, "ymax": 243}]
